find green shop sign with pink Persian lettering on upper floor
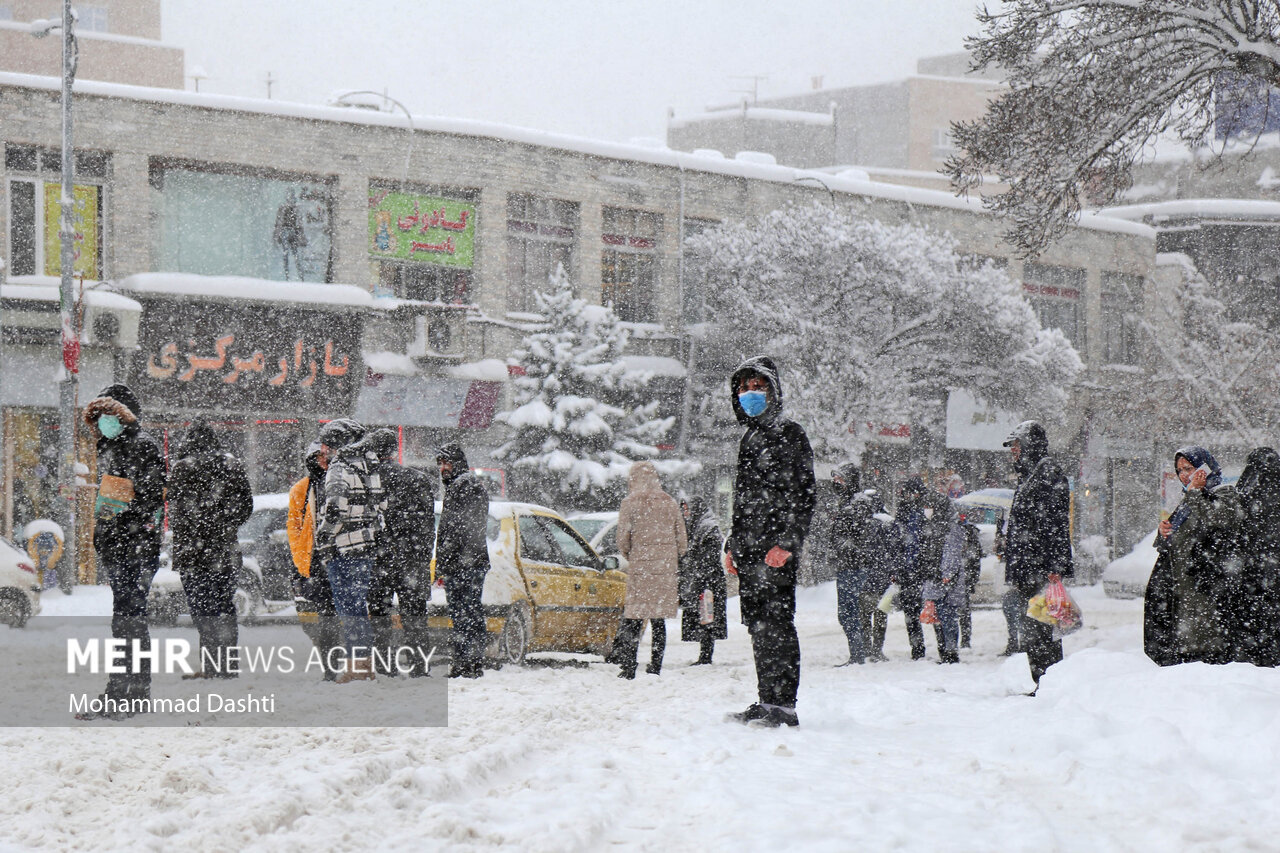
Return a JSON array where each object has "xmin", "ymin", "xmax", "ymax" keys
[{"xmin": 369, "ymin": 191, "xmax": 476, "ymax": 269}]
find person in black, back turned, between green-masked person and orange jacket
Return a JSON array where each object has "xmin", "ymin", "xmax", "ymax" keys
[{"xmin": 168, "ymin": 421, "xmax": 253, "ymax": 679}]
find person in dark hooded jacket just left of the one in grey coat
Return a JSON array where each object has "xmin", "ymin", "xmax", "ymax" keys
[{"xmin": 893, "ymin": 476, "xmax": 951, "ymax": 661}]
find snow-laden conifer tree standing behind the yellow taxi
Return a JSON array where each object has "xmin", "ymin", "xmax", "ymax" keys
[{"xmin": 494, "ymin": 266, "xmax": 696, "ymax": 508}]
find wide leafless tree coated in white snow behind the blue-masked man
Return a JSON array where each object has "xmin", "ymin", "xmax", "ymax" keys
[{"xmin": 691, "ymin": 205, "xmax": 1082, "ymax": 457}]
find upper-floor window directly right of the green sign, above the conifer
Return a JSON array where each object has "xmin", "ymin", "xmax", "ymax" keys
[{"xmin": 507, "ymin": 192, "xmax": 579, "ymax": 311}]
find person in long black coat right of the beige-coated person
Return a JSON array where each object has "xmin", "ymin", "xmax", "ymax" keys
[{"xmin": 680, "ymin": 497, "xmax": 728, "ymax": 666}]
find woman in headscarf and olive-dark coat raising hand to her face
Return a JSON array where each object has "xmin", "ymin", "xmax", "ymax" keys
[{"xmin": 1143, "ymin": 446, "xmax": 1240, "ymax": 666}]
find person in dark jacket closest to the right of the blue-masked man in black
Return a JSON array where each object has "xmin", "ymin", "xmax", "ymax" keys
[{"xmin": 829, "ymin": 462, "xmax": 881, "ymax": 666}]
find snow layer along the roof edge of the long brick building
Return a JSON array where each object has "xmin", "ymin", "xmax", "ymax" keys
[{"xmin": 0, "ymin": 72, "xmax": 1155, "ymax": 240}]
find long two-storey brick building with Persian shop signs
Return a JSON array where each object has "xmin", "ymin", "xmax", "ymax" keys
[{"xmin": 0, "ymin": 13, "xmax": 1155, "ymax": 560}]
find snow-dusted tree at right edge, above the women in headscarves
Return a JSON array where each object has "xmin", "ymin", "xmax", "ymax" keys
[{"xmin": 1134, "ymin": 253, "xmax": 1280, "ymax": 444}]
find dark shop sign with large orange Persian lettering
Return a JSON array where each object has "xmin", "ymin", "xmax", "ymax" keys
[{"xmin": 134, "ymin": 300, "xmax": 361, "ymax": 416}]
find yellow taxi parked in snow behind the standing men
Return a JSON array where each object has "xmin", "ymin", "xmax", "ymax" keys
[{"xmin": 428, "ymin": 501, "xmax": 626, "ymax": 663}]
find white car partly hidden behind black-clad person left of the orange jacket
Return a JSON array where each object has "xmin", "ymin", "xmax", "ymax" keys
[{"xmin": 147, "ymin": 493, "xmax": 296, "ymax": 625}]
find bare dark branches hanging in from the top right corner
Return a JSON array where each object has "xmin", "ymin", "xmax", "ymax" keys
[{"xmin": 945, "ymin": 0, "xmax": 1280, "ymax": 254}]
